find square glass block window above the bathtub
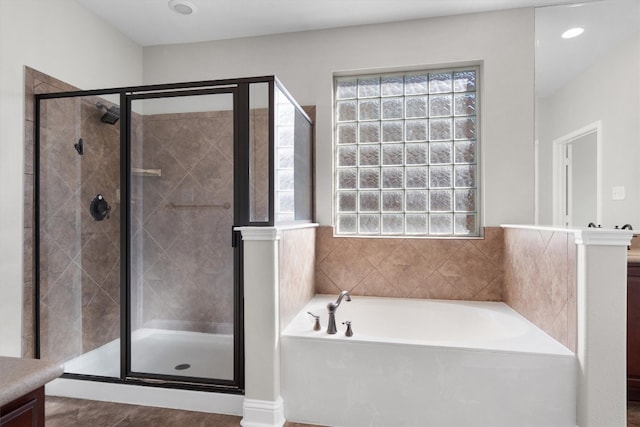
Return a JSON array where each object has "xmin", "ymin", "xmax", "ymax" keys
[{"xmin": 334, "ymin": 67, "xmax": 480, "ymax": 237}]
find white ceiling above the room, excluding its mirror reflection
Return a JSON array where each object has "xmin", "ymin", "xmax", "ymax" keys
[{"xmin": 76, "ymin": 0, "xmax": 592, "ymax": 46}]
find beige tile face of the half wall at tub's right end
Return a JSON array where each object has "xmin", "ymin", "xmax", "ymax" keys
[{"xmin": 504, "ymin": 228, "xmax": 576, "ymax": 351}]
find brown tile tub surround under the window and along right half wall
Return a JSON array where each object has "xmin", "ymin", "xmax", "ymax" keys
[{"xmin": 316, "ymin": 227, "xmax": 576, "ymax": 351}]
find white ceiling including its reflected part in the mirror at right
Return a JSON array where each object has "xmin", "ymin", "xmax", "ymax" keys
[{"xmin": 76, "ymin": 0, "xmax": 640, "ymax": 96}]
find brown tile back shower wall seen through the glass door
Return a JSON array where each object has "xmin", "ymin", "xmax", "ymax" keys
[{"xmin": 132, "ymin": 111, "xmax": 234, "ymax": 332}]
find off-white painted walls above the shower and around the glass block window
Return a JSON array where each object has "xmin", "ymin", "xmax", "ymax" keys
[{"xmin": 0, "ymin": 0, "xmax": 534, "ymax": 355}]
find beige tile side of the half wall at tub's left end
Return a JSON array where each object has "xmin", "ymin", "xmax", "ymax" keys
[{"xmin": 279, "ymin": 227, "xmax": 316, "ymax": 329}]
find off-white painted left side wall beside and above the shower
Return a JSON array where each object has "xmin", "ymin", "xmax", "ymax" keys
[{"xmin": 0, "ymin": 0, "xmax": 142, "ymax": 356}]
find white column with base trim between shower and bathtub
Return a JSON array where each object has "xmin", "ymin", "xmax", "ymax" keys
[{"xmin": 240, "ymin": 227, "xmax": 285, "ymax": 427}]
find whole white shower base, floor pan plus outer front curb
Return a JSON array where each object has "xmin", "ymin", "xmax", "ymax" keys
[{"xmin": 45, "ymin": 328, "xmax": 244, "ymax": 415}]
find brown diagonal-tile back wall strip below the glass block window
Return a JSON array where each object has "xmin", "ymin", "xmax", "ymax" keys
[{"xmin": 316, "ymin": 227, "xmax": 504, "ymax": 301}]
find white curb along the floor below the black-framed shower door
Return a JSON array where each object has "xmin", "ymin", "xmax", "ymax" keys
[{"xmin": 45, "ymin": 378, "xmax": 244, "ymax": 415}]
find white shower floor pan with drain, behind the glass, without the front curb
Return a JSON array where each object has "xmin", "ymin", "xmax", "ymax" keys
[{"xmin": 64, "ymin": 328, "xmax": 233, "ymax": 380}]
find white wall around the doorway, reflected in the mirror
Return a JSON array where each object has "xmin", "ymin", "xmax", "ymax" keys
[{"xmin": 538, "ymin": 33, "xmax": 640, "ymax": 228}]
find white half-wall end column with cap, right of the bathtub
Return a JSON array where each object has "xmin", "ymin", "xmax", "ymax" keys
[{"xmin": 576, "ymin": 228, "xmax": 632, "ymax": 427}]
